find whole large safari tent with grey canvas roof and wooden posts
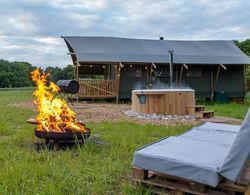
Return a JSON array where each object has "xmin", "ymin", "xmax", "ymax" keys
[{"xmin": 62, "ymin": 36, "xmax": 250, "ymax": 100}]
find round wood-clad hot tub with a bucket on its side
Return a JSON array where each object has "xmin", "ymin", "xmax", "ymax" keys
[{"xmin": 132, "ymin": 89, "xmax": 195, "ymax": 115}]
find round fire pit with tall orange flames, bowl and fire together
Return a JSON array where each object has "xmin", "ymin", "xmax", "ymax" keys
[{"xmin": 27, "ymin": 69, "xmax": 91, "ymax": 148}]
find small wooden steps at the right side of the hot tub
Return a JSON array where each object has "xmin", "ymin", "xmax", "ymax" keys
[{"xmin": 187, "ymin": 105, "xmax": 214, "ymax": 118}]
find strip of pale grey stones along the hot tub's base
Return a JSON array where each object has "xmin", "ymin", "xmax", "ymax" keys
[{"xmin": 124, "ymin": 110, "xmax": 198, "ymax": 121}]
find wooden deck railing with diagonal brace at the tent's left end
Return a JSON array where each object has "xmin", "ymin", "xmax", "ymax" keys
[{"xmin": 79, "ymin": 79, "xmax": 118, "ymax": 98}]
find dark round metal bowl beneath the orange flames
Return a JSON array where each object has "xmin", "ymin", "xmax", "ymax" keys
[{"xmin": 35, "ymin": 128, "xmax": 91, "ymax": 142}]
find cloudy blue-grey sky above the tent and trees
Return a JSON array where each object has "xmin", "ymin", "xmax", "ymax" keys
[{"xmin": 0, "ymin": 0, "xmax": 250, "ymax": 67}]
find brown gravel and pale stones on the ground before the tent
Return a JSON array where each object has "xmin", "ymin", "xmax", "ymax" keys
[{"xmin": 11, "ymin": 101, "xmax": 199, "ymax": 126}]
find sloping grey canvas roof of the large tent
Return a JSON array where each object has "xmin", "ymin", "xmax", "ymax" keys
[{"xmin": 62, "ymin": 36, "xmax": 250, "ymax": 64}]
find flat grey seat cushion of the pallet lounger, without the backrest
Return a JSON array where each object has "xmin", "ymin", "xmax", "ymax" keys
[{"xmin": 133, "ymin": 123, "xmax": 240, "ymax": 187}]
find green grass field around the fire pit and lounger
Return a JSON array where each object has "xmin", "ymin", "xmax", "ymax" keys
[{"xmin": 0, "ymin": 91, "xmax": 249, "ymax": 194}]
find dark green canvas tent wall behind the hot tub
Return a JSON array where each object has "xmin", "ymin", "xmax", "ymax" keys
[{"xmin": 119, "ymin": 64, "xmax": 245, "ymax": 99}]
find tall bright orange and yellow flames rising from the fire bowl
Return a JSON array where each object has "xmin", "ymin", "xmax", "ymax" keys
[{"xmin": 32, "ymin": 68, "xmax": 86, "ymax": 132}]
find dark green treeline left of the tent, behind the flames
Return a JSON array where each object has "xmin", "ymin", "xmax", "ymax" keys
[{"xmin": 0, "ymin": 60, "xmax": 74, "ymax": 88}]
